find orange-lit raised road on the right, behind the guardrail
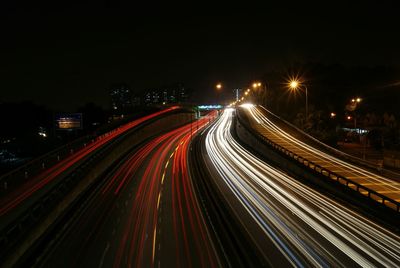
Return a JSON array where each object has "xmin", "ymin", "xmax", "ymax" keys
[{"xmin": 240, "ymin": 105, "xmax": 400, "ymax": 209}]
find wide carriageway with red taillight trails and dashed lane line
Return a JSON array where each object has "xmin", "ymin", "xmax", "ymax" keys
[{"xmin": 32, "ymin": 115, "xmax": 220, "ymax": 267}]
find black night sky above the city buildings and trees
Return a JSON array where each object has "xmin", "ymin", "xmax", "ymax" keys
[{"xmin": 0, "ymin": 0, "xmax": 400, "ymax": 110}]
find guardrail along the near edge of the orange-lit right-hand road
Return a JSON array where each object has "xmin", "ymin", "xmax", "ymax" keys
[{"xmin": 235, "ymin": 110, "xmax": 400, "ymax": 212}]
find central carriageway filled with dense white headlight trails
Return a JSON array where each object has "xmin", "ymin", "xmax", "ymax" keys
[{"xmin": 202, "ymin": 108, "xmax": 400, "ymax": 267}]
